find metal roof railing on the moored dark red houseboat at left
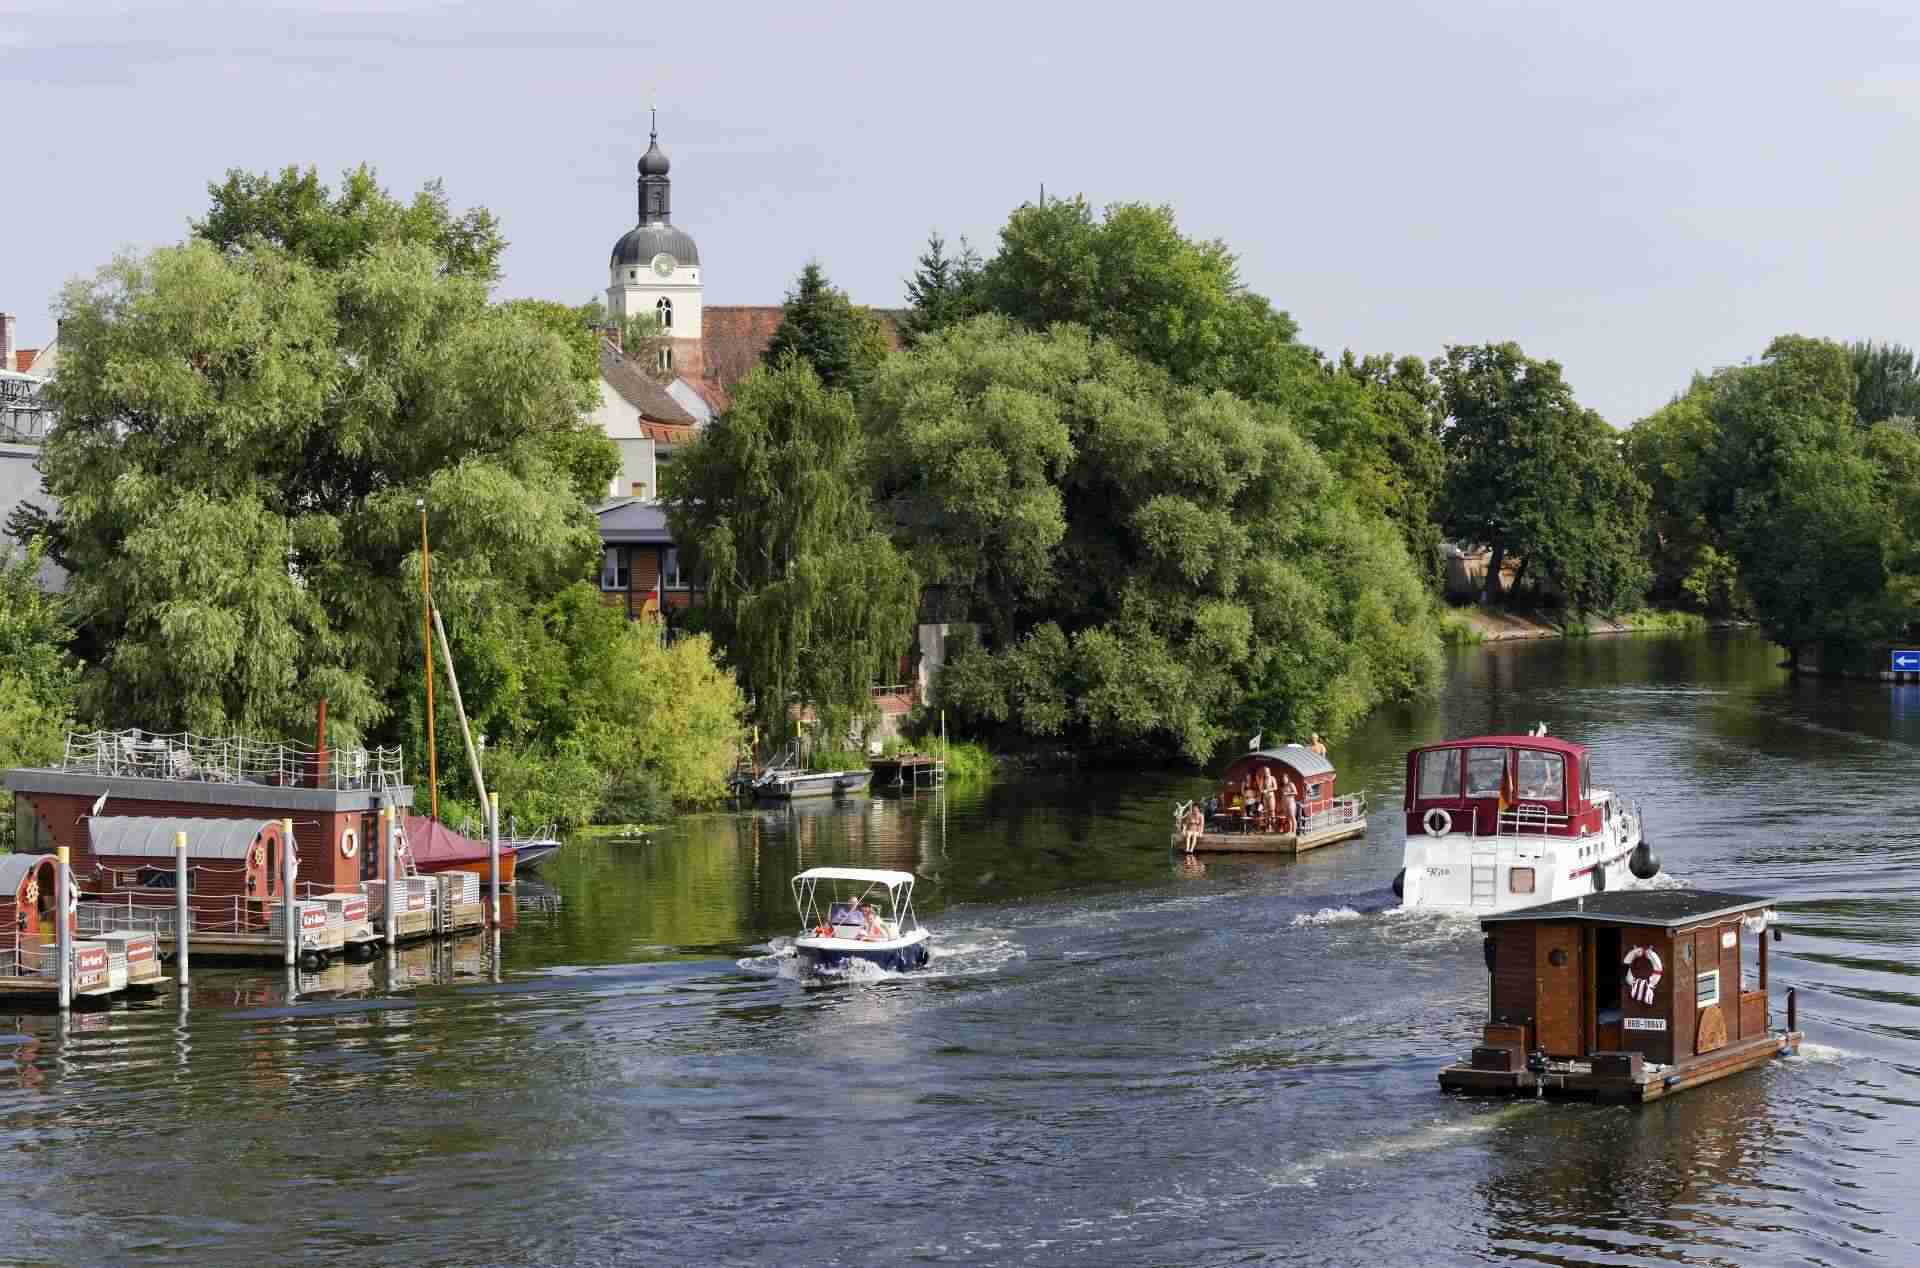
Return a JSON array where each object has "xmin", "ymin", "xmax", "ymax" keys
[{"xmin": 58, "ymin": 728, "xmax": 403, "ymax": 790}]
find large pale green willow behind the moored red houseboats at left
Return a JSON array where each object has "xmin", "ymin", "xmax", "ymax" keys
[{"xmin": 42, "ymin": 204, "xmax": 616, "ymax": 749}]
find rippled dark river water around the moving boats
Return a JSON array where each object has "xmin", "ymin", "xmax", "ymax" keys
[{"xmin": 0, "ymin": 636, "xmax": 1920, "ymax": 1266}]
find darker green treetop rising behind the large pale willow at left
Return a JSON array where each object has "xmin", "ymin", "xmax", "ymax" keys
[{"xmin": 192, "ymin": 163, "xmax": 507, "ymax": 282}]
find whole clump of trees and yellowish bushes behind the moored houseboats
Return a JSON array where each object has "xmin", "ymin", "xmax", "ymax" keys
[{"xmin": 13, "ymin": 169, "xmax": 739, "ymax": 824}]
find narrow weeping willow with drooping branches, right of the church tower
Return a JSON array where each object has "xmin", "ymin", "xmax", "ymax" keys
[{"xmin": 666, "ymin": 355, "xmax": 918, "ymax": 736}]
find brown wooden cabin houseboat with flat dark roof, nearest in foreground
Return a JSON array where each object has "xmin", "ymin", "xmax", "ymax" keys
[{"xmin": 1440, "ymin": 890, "xmax": 1801, "ymax": 1101}]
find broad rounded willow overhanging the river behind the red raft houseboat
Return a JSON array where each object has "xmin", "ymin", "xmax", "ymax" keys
[{"xmin": 862, "ymin": 317, "xmax": 1438, "ymax": 761}]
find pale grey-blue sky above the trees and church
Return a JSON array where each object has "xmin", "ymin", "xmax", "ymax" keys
[{"xmin": 0, "ymin": 0, "xmax": 1920, "ymax": 427}]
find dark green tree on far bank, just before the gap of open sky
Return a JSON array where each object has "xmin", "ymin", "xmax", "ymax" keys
[{"xmin": 1432, "ymin": 344, "xmax": 1649, "ymax": 613}]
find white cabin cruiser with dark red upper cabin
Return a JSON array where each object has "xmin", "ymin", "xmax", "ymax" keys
[{"xmin": 1394, "ymin": 732, "xmax": 1661, "ymax": 913}]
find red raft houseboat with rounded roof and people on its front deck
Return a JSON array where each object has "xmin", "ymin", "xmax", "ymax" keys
[{"xmin": 1173, "ymin": 744, "xmax": 1367, "ymax": 855}]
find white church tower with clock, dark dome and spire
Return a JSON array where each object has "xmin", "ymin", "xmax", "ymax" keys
[{"xmin": 607, "ymin": 113, "xmax": 701, "ymax": 370}]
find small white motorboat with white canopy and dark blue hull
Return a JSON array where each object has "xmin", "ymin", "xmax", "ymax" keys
[{"xmin": 793, "ymin": 866, "xmax": 933, "ymax": 976}]
